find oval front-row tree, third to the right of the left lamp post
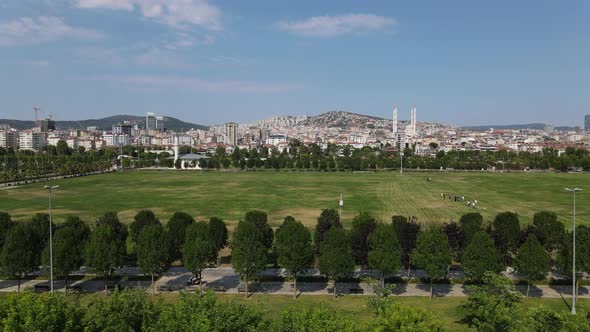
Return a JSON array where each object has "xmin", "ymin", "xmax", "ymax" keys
[{"xmin": 137, "ymin": 224, "xmax": 168, "ymax": 294}]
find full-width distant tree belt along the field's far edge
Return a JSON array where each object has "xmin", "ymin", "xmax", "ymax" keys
[{"xmin": 0, "ymin": 140, "xmax": 590, "ymax": 182}]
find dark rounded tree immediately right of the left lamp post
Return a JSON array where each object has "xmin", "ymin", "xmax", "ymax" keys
[{"xmin": 43, "ymin": 227, "xmax": 85, "ymax": 294}]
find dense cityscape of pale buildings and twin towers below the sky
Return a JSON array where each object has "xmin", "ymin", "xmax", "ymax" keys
[{"xmin": 0, "ymin": 107, "xmax": 590, "ymax": 157}]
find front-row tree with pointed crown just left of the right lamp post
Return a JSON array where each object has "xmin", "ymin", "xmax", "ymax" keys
[{"xmin": 515, "ymin": 234, "xmax": 551, "ymax": 297}]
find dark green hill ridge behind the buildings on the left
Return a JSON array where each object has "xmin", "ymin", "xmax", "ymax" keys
[{"xmin": 0, "ymin": 115, "xmax": 209, "ymax": 131}]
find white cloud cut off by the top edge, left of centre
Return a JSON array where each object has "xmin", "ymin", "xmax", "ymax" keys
[{"xmin": 74, "ymin": 0, "xmax": 222, "ymax": 31}]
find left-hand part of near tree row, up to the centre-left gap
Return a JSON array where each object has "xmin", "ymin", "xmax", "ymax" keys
[{"xmin": 0, "ymin": 210, "xmax": 228, "ymax": 291}]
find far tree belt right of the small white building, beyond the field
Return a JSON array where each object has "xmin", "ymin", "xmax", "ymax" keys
[{"xmin": 192, "ymin": 142, "xmax": 590, "ymax": 171}]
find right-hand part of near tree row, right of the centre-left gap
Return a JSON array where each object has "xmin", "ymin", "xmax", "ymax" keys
[{"xmin": 232, "ymin": 210, "xmax": 590, "ymax": 296}]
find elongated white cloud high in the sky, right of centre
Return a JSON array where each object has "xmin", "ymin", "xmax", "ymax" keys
[{"xmin": 277, "ymin": 14, "xmax": 397, "ymax": 37}]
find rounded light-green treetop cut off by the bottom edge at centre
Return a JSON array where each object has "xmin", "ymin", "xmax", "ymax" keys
[{"xmin": 273, "ymin": 307, "xmax": 358, "ymax": 332}]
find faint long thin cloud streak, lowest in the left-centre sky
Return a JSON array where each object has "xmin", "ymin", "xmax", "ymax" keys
[{"xmin": 104, "ymin": 75, "xmax": 293, "ymax": 93}]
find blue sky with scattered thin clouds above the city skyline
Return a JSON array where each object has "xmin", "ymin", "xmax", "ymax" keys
[{"xmin": 0, "ymin": 0, "xmax": 590, "ymax": 125}]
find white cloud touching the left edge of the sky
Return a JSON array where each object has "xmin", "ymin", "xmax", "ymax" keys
[{"xmin": 0, "ymin": 16, "xmax": 104, "ymax": 46}]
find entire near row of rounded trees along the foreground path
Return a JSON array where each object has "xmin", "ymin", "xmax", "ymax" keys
[{"xmin": 0, "ymin": 209, "xmax": 590, "ymax": 296}]
